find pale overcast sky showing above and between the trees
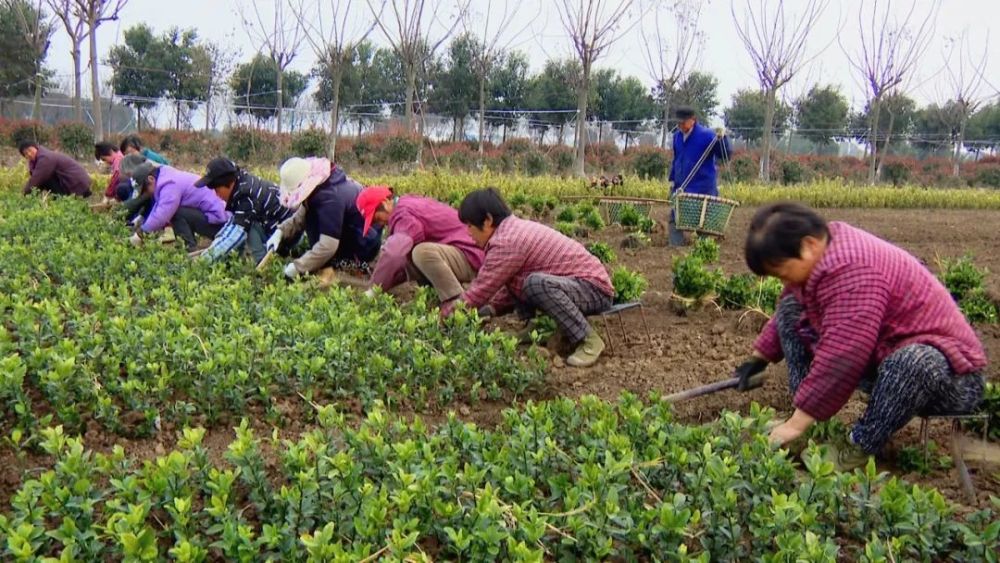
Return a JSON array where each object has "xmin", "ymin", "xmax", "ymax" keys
[{"xmin": 43, "ymin": 0, "xmax": 1000, "ymax": 118}]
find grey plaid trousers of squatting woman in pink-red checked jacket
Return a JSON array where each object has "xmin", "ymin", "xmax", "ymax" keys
[{"xmin": 518, "ymin": 274, "xmax": 611, "ymax": 346}]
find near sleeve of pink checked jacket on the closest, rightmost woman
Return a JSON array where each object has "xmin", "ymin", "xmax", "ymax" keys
[{"xmin": 793, "ymin": 265, "xmax": 890, "ymax": 420}]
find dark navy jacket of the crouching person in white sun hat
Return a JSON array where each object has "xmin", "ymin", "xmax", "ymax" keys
[{"xmin": 305, "ymin": 168, "xmax": 382, "ymax": 262}]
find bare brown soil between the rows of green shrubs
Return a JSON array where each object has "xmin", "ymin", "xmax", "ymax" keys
[{"xmin": 0, "ymin": 208, "xmax": 1000, "ymax": 506}]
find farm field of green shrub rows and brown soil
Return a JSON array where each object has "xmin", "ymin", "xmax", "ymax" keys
[{"xmin": 0, "ymin": 174, "xmax": 1000, "ymax": 561}]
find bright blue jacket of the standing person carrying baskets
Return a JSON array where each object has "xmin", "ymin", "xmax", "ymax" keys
[{"xmin": 670, "ymin": 123, "xmax": 733, "ymax": 196}]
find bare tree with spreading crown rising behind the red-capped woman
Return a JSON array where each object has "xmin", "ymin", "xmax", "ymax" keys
[{"xmin": 366, "ymin": 0, "xmax": 469, "ymax": 130}]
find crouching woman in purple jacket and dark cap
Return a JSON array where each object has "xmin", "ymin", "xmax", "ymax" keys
[{"xmin": 132, "ymin": 162, "xmax": 229, "ymax": 252}]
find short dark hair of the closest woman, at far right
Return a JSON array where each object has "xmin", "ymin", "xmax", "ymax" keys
[{"xmin": 744, "ymin": 202, "xmax": 830, "ymax": 276}]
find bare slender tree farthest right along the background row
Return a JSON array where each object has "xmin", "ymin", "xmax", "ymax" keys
[{"xmin": 944, "ymin": 30, "xmax": 990, "ymax": 178}]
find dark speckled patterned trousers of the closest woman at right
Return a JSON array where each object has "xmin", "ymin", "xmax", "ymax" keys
[{"xmin": 777, "ymin": 296, "xmax": 983, "ymax": 454}]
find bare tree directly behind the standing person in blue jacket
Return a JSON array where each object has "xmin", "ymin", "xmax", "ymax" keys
[{"xmin": 639, "ymin": 0, "xmax": 705, "ymax": 149}]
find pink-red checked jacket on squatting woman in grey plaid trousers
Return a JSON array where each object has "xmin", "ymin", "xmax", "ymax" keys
[{"xmin": 450, "ymin": 216, "xmax": 615, "ymax": 314}]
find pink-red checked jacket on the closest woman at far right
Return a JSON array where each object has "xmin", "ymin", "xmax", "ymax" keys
[{"xmin": 754, "ymin": 222, "xmax": 986, "ymax": 420}]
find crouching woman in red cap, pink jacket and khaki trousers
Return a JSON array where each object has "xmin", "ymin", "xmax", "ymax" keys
[{"xmin": 357, "ymin": 186, "xmax": 483, "ymax": 303}]
